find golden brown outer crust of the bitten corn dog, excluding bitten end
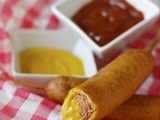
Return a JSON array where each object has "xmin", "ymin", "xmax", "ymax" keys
[{"xmin": 76, "ymin": 49, "xmax": 154, "ymax": 119}]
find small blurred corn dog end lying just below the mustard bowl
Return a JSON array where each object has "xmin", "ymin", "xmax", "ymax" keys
[{"xmin": 44, "ymin": 76, "xmax": 86, "ymax": 105}]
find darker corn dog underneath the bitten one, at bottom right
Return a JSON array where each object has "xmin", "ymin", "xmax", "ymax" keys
[{"xmin": 102, "ymin": 95, "xmax": 160, "ymax": 120}]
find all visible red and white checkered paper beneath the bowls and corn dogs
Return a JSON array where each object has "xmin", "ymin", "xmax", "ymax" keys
[{"xmin": 0, "ymin": 0, "xmax": 160, "ymax": 120}]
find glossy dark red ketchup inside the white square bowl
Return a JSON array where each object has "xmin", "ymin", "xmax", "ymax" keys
[{"xmin": 73, "ymin": 0, "xmax": 144, "ymax": 46}]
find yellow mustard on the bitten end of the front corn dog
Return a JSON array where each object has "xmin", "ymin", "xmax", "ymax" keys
[{"xmin": 61, "ymin": 92, "xmax": 81, "ymax": 120}]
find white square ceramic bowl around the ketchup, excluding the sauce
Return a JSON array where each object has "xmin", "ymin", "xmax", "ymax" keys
[{"xmin": 51, "ymin": 0, "xmax": 160, "ymax": 56}]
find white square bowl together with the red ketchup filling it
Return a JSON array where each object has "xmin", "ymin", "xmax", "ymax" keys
[{"xmin": 52, "ymin": 0, "xmax": 159, "ymax": 57}]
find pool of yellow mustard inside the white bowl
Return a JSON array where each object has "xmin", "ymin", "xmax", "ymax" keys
[{"xmin": 19, "ymin": 47, "xmax": 84, "ymax": 75}]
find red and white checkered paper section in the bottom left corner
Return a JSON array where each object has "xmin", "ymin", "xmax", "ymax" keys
[{"xmin": 0, "ymin": 81, "xmax": 62, "ymax": 120}]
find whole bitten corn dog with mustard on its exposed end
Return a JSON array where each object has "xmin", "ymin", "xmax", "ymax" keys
[{"xmin": 62, "ymin": 39, "xmax": 158, "ymax": 120}]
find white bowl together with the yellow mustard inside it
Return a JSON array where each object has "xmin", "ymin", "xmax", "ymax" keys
[{"xmin": 11, "ymin": 28, "xmax": 97, "ymax": 85}]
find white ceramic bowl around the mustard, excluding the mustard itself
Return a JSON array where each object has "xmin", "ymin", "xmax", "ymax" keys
[{"xmin": 11, "ymin": 28, "xmax": 97, "ymax": 85}]
